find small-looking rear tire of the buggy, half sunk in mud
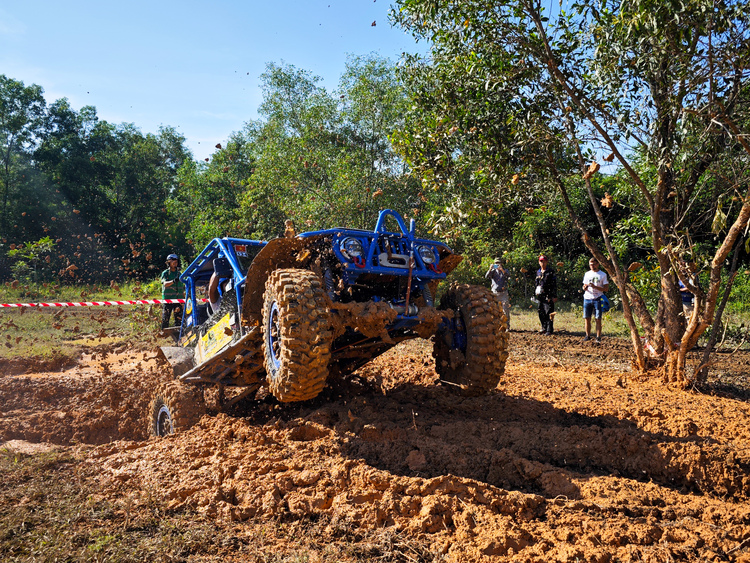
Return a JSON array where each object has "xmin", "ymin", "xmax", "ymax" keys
[{"xmin": 148, "ymin": 381, "xmax": 206, "ymax": 436}]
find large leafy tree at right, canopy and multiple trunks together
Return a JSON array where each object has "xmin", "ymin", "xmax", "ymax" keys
[{"xmin": 393, "ymin": 0, "xmax": 750, "ymax": 384}]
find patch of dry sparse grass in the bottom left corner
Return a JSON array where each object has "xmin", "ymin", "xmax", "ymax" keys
[{"xmin": 0, "ymin": 449, "xmax": 217, "ymax": 562}]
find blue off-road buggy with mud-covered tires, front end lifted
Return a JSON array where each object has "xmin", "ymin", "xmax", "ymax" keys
[{"xmin": 149, "ymin": 210, "xmax": 508, "ymax": 435}]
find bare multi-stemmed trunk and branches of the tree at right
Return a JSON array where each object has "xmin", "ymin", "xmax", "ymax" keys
[{"xmin": 521, "ymin": 1, "xmax": 750, "ymax": 381}]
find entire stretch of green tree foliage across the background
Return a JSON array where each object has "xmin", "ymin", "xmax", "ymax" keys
[{"xmin": 0, "ymin": 28, "xmax": 750, "ymax": 350}]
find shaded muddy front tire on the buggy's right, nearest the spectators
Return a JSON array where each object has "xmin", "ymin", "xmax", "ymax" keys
[{"xmin": 433, "ymin": 284, "xmax": 508, "ymax": 395}]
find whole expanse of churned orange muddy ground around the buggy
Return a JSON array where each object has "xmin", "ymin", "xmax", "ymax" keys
[{"xmin": 0, "ymin": 332, "xmax": 750, "ymax": 562}]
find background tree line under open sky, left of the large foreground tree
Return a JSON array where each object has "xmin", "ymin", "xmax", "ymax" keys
[{"xmin": 0, "ymin": 56, "xmax": 422, "ymax": 281}]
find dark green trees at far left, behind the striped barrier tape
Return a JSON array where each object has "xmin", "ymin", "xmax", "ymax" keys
[{"xmin": 0, "ymin": 76, "xmax": 194, "ymax": 281}]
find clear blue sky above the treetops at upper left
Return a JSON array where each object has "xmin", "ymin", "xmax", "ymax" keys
[{"xmin": 0, "ymin": 0, "xmax": 425, "ymax": 159}]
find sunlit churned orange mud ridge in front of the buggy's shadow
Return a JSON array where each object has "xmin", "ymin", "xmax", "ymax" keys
[{"xmin": 91, "ymin": 395, "xmax": 750, "ymax": 562}]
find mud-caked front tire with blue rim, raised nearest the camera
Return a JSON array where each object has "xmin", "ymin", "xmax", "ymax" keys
[{"xmin": 263, "ymin": 269, "xmax": 333, "ymax": 403}]
